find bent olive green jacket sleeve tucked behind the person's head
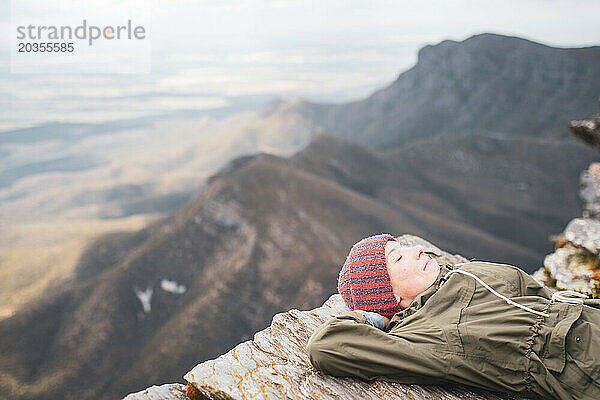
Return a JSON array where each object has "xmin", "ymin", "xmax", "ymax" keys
[{"xmin": 308, "ymin": 312, "xmax": 449, "ymax": 384}]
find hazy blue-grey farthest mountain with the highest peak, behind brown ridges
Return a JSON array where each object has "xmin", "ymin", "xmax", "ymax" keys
[{"xmin": 287, "ymin": 33, "xmax": 600, "ymax": 150}]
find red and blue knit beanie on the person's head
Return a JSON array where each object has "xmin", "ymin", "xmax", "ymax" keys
[{"xmin": 338, "ymin": 233, "xmax": 400, "ymax": 317}]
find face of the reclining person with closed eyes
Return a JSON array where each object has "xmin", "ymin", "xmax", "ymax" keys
[{"xmin": 385, "ymin": 240, "xmax": 440, "ymax": 309}]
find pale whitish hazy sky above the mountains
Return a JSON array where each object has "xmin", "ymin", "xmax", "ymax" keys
[{"xmin": 0, "ymin": 0, "xmax": 600, "ymax": 131}]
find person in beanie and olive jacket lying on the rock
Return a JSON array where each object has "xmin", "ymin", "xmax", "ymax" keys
[{"xmin": 308, "ymin": 234, "xmax": 600, "ymax": 400}]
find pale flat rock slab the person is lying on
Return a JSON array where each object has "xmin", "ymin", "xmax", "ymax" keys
[{"xmin": 120, "ymin": 235, "xmax": 515, "ymax": 400}]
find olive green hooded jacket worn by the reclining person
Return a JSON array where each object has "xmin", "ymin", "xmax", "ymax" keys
[{"xmin": 308, "ymin": 261, "xmax": 600, "ymax": 400}]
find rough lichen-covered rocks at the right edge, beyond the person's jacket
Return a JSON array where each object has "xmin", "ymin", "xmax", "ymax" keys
[{"xmin": 534, "ymin": 108, "xmax": 600, "ymax": 298}]
